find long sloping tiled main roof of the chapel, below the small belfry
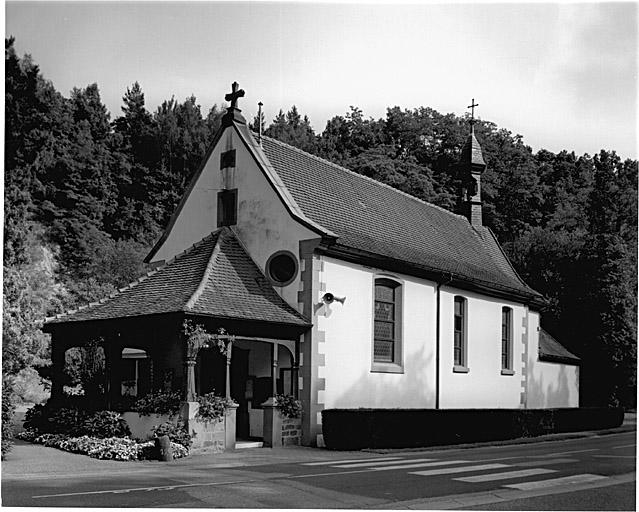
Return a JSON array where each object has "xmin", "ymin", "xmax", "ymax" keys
[{"xmin": 262, "ymin": 133, "xmax": 541, "ymax": 300}]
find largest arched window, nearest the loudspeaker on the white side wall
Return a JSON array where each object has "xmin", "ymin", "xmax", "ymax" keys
[{"xmin": 373, "ymin": 278, "xmax": 402, "ymax": 371}]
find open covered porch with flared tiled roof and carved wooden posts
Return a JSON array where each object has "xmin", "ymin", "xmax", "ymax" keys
[{"xmin": 44, "ymin": 228, "xmax": 310, "ymax": 446}]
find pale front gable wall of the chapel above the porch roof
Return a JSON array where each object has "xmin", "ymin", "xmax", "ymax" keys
[{"xmin": 152, "ymin": 129, "xmax": 318, "ymax": 307}]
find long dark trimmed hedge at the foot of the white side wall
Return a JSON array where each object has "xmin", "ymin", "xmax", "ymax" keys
[{"xmin": 322, "ymin": 407, "xmax": 624, "ymax": 450}]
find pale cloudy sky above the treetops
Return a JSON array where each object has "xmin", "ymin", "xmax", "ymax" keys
[{"xmin": 5, "ymin": 1, "xmax": 638, "ymax": 158}]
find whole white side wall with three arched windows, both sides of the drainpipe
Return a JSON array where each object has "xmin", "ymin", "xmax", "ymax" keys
[{"xmin": 315, "ymin": 257, "xmax": 540, "ymax": 408}]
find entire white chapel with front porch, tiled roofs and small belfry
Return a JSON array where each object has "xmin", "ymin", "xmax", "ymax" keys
[{"xmin": 45, "ymin": 84, "xmax": 579, "ymax": 445}]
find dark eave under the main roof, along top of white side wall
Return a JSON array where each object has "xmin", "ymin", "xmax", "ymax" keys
[{"xmin": 318, "ymin": 243, "xmax": 547, "ymax": 310}]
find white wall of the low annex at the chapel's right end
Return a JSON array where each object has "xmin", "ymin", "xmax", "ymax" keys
[{"xmin": 526, "ymin": 313, "xmax": 579, "ymax": 409}]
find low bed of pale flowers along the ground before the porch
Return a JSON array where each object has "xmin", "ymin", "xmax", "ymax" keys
[{"xmin": 17, "ymin": 430, "xmax": 189, "ymax": 460}]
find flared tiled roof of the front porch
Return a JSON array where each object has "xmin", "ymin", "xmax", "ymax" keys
[{"xmin": 47, "ymin": 228, "xmax": 309, "ymax": 326}]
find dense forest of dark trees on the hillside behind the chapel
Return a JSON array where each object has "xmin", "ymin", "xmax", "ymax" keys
[{"xmin": 2, "ymin": 39, "xmax": 637, "ymax": 422}]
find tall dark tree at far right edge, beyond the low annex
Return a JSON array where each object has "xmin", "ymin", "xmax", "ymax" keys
[{"xmin": 582, "ymin": 151, "xmax": 637, "ymax": 406}]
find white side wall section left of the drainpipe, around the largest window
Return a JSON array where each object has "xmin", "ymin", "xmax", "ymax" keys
[{"xmin": 315, "ymin": 257, "xmax": 435, "ymax": 408}]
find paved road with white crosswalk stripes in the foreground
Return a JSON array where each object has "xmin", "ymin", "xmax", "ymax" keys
[{"xmin": 2, "ymin": 432, "xmax": 636, "ymax": 510}]
